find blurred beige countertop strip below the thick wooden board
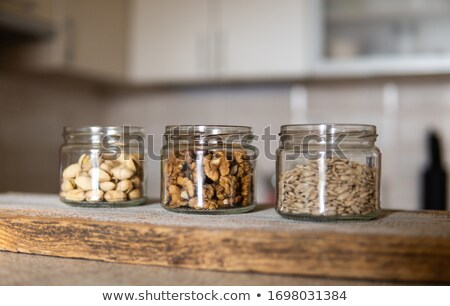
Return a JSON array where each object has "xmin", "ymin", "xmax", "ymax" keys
[{"xmin": 0, "ymin": 252, "xmax": 397, "ymax": 286}]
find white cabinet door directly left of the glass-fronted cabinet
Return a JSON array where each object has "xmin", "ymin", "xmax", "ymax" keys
[{"xmin": 215, "ymin": 0, "xmax": 314, "ymax": 78}]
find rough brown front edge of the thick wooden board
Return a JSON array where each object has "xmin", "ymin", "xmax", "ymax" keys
[{"xmin": 0, "ymin": 214, "xmax": 450, "ymax": 283}]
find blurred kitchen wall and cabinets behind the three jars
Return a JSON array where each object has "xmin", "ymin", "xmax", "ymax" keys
[{"xmin": 0, "ymin": 0, "xmax": 450, "ymax": 209}]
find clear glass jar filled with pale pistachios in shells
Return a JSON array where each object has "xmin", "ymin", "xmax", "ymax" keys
[{"xmin": 59, "ymin": 126, "xmax": 146, "ymax": 207}]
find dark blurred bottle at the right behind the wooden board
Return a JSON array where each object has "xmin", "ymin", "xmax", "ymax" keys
[{"xmin": 422, "ymin": 132, "xmax": 447, "ymax": 210}]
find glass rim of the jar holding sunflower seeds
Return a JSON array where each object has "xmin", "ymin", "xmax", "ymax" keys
[{"xmin": 280, "ymin": 123, "xmax": 377, "ymax": 136}]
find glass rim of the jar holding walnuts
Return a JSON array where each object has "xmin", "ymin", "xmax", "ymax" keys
[{"xmin": 165, "ymin": 124, "xmax": 253, "ymax": 136}]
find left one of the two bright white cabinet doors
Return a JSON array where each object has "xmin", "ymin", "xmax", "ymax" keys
[{"xmin": 128, "ymin": 0, "xmax": 210, "ymax": 82}]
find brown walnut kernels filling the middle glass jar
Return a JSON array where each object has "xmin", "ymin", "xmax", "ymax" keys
[{"xmin": 163, "ymin": 150, "xmax": 253, "ymax": 210}]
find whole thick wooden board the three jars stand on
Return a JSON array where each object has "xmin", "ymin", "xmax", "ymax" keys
[{"xmin": 0, "ymin": 194, "xmax": 450, "ymax": 283}]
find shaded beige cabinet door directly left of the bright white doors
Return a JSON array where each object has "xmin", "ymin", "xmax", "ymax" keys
[{"xmin": 65, "ymin": 0, "xmax": 128, "ymax": 80}]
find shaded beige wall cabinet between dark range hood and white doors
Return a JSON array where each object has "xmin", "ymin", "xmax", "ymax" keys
[{"xmin": 8, "ymin": 0, "xmax": 131, "ymax": 82}]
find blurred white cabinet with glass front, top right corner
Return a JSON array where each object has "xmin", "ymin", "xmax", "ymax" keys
[{"xmin": 315, "ymin": 0, "xmax": 450, "ymax": 77}]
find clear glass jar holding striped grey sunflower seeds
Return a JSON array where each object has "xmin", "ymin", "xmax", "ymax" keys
[{"xmin": 276, "ymin": 124, "xmax": 381, "ymax": 221}]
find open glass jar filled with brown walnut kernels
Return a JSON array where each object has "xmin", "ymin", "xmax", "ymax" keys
[{"xmin": 161, "ymin": 125, "xmax": 257, "ymax": 214}]
